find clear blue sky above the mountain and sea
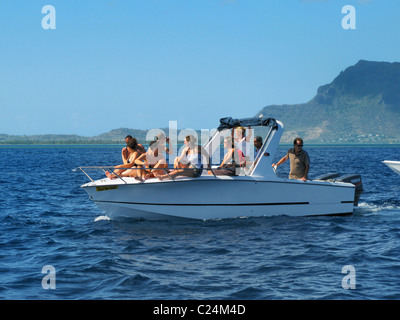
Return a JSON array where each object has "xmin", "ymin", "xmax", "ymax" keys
[{"xmin": 0, "ymin": 0, "xmax": 400, "ymax": 136}]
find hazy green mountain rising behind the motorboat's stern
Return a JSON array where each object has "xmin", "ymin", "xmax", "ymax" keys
[{"xmin": 256, "ymin": 60, "xmax": 400, "ymax": 143}]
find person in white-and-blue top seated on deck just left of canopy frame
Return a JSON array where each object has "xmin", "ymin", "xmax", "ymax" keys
[{"xmin": 156, "ymin": 135, "xmax": 207, "ymax": 180}]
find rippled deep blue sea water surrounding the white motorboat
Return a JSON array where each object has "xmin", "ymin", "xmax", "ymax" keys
[{"xmin": 0, "ymin": 146, "xmax": 400, "ymax": 299}]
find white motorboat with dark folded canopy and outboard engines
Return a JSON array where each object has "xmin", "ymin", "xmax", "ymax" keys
[{"xmin": 74, "ymin": 118, "xmax": 362, "ymax": 220}]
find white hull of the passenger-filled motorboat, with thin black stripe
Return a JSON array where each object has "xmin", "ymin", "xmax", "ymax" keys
[{"xmin": 82, "ymin": 177, "xmax": 355, "ymax": 220}]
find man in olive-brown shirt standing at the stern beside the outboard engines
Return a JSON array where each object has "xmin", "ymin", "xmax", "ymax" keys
[{"xmin": 272, "ymin": 138, "xmax": 310, "ymax": 181}]
